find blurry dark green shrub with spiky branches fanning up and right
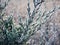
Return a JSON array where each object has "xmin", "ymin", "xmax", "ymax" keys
[{"xmin": 0, "ymin": 0, "xmax": 60, "ymax": 45}]
